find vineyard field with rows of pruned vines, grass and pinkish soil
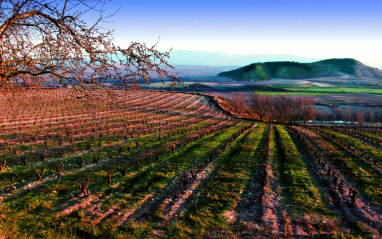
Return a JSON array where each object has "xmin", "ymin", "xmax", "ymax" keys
[{"xmin": 0, "ymin": 89, "xmax": 382, "ymax": 238}]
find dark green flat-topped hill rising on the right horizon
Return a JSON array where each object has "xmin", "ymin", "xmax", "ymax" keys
[{"xmin": 218, "ymin": 58, "xmax": 382, "ymax": 80}]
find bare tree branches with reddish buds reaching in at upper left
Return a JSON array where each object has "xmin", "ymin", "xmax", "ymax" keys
[{"xmin": 0, "ymin": 0, "xmax": 181, "ymax": 93}]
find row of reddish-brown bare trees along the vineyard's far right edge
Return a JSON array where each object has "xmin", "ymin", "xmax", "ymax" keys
[{"xmin": 227, "ymin": 92, "xmax": 382, "ymax": 125}]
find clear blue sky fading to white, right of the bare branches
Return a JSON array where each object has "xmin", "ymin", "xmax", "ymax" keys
[{"xmin": 92, "ymin": 0, "xmax": 382, "ymax": 69}]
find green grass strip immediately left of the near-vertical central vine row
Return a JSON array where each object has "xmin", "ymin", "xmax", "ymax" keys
[{"xmin": 179, "ymin": 125, "xmax": 265, "ymax": 237}]
